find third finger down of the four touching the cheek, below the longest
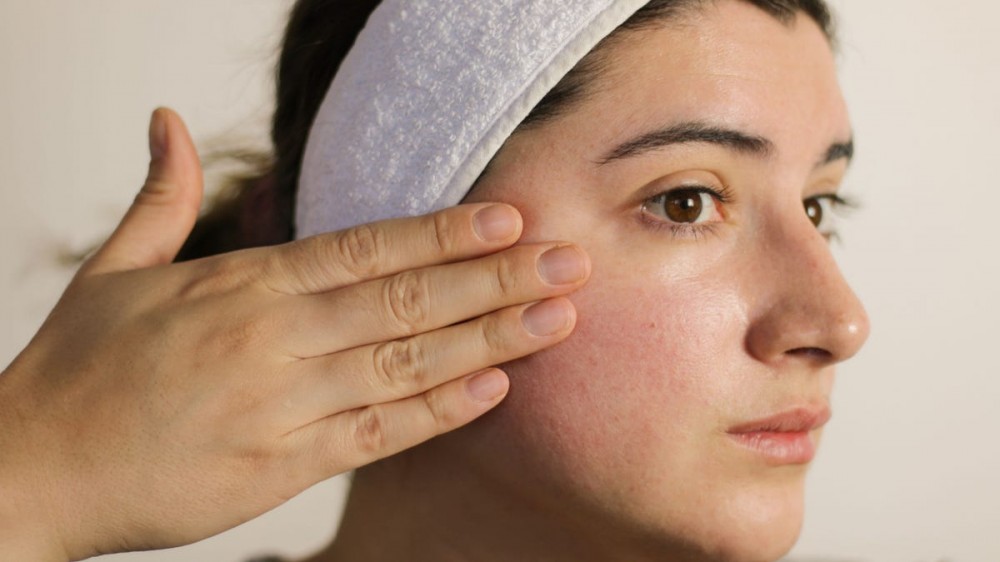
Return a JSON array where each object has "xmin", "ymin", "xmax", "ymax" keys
[{"xmin": 280, "ymin": 297, "xmax": 576, "ymax": 427}]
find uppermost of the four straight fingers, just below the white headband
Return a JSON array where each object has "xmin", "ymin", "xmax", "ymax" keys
[{"xmin": 262, "ymin": 204, "xmax": 522, "ymax": 294}]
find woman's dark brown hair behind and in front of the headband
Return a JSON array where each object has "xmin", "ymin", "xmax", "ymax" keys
[{"xmin": 177, "ymin": 0, "xmax": 835, "ymax": 261}]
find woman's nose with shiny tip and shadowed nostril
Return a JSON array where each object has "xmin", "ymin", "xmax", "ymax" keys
[{"xmin": 746, "ymin": 213, "xmax": 870, "ymax": 366}]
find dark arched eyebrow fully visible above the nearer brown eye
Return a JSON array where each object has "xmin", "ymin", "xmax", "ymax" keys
[{"xmin": 597, "ymin": 122, "xmax": 776, "ymax": 166}]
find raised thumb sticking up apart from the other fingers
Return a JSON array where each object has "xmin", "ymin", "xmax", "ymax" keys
[{"xmin": 81, "ymin": 108, "xmax": 202, "ymax": 275}]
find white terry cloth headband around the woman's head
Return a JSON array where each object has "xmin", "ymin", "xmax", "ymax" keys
[{"xmin": 296, "ymin": 0, "xmax": 648, "ymax": 238}]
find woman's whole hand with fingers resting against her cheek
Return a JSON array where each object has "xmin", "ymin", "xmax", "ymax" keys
[{"xmin": 0, "ymin": 110, "xmax": 590, "ymax": 560}]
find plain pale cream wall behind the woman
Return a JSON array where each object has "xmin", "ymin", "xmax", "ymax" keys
[{"xmin": 0, "ymin": 0, "xmax": 1000, "ymax": 562}]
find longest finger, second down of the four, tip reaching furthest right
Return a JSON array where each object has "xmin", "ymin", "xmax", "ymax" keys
[{"xmin": 281, "ymin": 244, "xmax": 590, "ymax": 357}]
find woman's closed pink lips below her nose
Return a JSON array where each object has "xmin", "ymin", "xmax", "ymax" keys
[{"xmin": 727, "ymin": 407, "xmax": 831, "ymax": 466}]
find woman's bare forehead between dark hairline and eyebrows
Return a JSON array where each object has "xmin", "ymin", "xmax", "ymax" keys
[{"xmin": 544, "ymin": 0, "xmax": 851, "ymax": 160}]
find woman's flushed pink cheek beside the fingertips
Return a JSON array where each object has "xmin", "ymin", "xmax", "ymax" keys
[{"xmin": 494, "ymin": 268, "xmax": 745, "ymax": 489}]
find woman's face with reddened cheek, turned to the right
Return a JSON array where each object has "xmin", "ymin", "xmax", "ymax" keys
[{"xmin": 455, "ymin": 1, "xmax": 868, "ymax": 560}]
